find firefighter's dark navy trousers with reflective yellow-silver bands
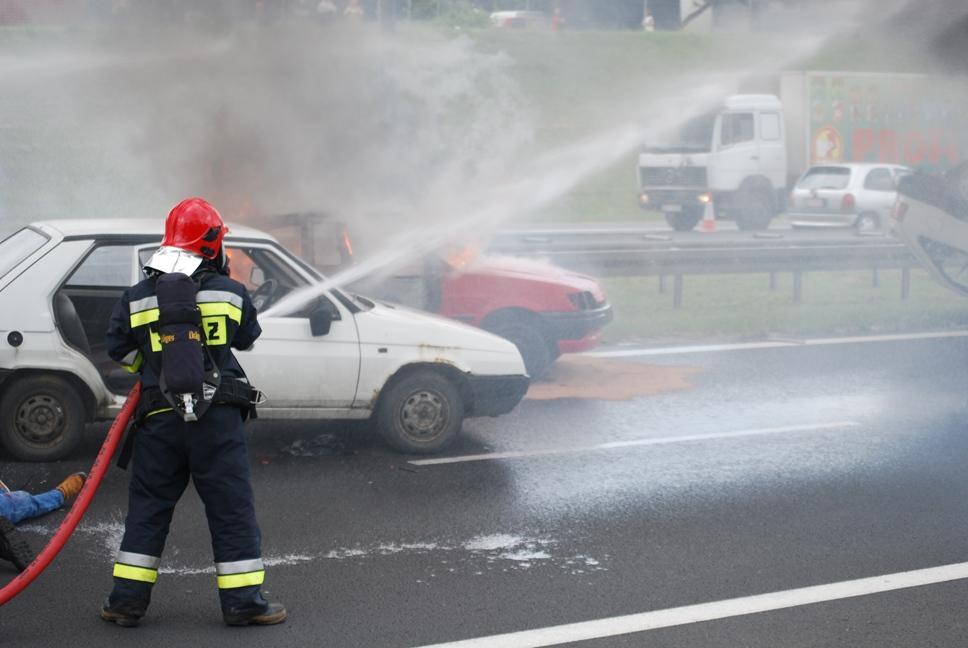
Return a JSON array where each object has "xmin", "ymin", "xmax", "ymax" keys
[{"xmin": 109, "ymin": 405, "xmax": 265, "ymax": 609}]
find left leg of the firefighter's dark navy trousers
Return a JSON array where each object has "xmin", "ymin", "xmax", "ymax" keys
[{"xmin": 109, "ymin": 412, "xmax": 189, "ymax": 607}]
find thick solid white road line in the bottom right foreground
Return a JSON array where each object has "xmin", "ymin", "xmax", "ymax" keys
[{"xmin": 421, "ymin": 562, "xmax": 968, "ymax": 648}]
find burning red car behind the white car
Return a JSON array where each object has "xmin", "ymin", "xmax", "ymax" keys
[{"xmin": 273, "ymin": 213, "xmax": 612, "ymax": 378}]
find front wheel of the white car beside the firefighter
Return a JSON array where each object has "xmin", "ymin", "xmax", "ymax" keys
[{"xmin": 376, "ymin": 369, "xmax": 464, "ymax": 454}]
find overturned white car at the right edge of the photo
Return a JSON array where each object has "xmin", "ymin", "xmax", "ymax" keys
[{"xmin": 893, "ymin": 164, "xmax": 968, "ymax": 295}]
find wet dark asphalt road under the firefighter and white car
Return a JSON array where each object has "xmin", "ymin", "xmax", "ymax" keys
[{"xmin": 0, "ymin": 337, "xmax": 968, "ymax": 648}]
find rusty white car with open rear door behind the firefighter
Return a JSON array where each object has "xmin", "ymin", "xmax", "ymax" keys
[{"xmin": 0, "ymin": 219, "xmax": 529, "ymax": 461}]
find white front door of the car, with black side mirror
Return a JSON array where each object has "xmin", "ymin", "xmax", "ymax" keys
[{"xmin": 143, "ymin": 240, "xmax": 360, "ymax": 418}]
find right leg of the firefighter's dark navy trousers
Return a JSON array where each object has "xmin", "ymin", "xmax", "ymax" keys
[{"xmin": 187, "ymin": 405, "xmax": 266, "ymax": 611}]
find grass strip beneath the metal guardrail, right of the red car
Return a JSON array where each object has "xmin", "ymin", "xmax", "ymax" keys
[{"xmin": 601, "ymin": 270, "xmax": 968, "ymax": 344}]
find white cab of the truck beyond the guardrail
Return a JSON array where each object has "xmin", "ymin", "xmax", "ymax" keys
[{"xmin": 638, "ymin": 95, "xmax": 787, "ymax": 231}]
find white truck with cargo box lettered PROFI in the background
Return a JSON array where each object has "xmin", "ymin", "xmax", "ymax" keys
[{"xmin": 638, "ymin": 72, "xmax": 965, "ymax": 231}]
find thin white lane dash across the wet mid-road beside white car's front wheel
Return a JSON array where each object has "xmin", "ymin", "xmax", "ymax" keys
[{"xmin": 407, "ymin": 421, "xmax": 860, "ymax": 466}]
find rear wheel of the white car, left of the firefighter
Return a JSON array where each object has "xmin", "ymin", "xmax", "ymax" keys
[{"xmin": 0, "ymin": 376, "xmax": 86, "ymax": 461}]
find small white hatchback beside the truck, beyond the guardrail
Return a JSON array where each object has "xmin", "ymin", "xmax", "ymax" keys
[{"xmin": 787, "ymin": 163, "xmax": 912, "ymax": 231}]
